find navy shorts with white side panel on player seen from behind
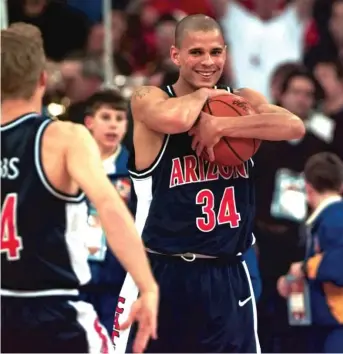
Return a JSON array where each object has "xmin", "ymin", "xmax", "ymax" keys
[{"xmin": 1, "ymin": 296, "xmax": 114, "ymax": 353}]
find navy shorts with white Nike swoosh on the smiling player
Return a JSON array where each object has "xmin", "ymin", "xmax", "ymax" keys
[{"xmin": 127, "ymin": 253, "xmax": 260, "ymax": 353}]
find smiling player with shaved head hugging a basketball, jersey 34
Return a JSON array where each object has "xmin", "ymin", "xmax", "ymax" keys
[{"xmin": 115, "ymin": 15, "xmax": 304, "ymax": 353}]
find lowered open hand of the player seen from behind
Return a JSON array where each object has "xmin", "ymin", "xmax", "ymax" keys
[{"xmin": 120, "ymin": 290, "xmax": 159, "ymax": 353}]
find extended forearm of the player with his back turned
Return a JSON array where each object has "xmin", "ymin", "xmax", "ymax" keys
[{"xmin": 98, "ymin": 198, "xmax": 157, "ymax": 292}]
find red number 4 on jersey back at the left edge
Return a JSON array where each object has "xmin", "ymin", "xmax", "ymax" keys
[{"xmin": 1, "ymin": 193, "xmax": 23, "ymax": 261}]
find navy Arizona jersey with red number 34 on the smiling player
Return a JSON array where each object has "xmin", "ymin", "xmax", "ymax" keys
[{"xmin": 128, "ymin": 86, "xmax": 255, "ymax": 256}]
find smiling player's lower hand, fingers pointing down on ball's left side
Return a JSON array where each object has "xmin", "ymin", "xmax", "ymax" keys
[{"xmin": 188, "ymin": 110, "xmax": 220, "ymax": 161}]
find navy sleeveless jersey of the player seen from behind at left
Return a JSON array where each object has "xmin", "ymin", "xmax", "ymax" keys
[{"xmin": 1, "ymin": 113, "xmax": 90, "ymax": 296}]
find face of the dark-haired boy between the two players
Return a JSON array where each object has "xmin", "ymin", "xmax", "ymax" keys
[{"xmin": 86, "ymin": 105, "xmax": 127, "ymax": 150}]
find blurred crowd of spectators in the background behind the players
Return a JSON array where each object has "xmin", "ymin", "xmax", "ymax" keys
[{"xmin": 4, "ymin": 0, "xmax": 343, "ymax": 352}]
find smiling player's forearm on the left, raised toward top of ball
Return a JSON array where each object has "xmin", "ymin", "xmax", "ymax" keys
[{"xmin": 156, "ymin": 89, "xmax": 208, "ymax": 133}]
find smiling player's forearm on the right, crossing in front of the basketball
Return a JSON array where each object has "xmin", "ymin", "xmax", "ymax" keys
[{"xmin": 216, "ymin": 112, "xmax": 305, "ymax": 141}]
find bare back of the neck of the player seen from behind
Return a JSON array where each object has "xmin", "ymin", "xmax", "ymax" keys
[{"xmin": 1, "ymin": 99, "xmax": 42, "ymax": 124}]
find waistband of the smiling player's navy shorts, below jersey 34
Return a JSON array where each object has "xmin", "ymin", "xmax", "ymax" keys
[{"xmin": 146, "ymin": 248, "xmax": 242, "ymax": 264}]
